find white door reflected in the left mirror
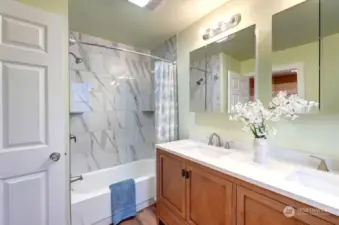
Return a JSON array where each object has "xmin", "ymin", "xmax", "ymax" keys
[{"xmin": 228, "ymin": 71, "xmax": 250, "ymax": 112}]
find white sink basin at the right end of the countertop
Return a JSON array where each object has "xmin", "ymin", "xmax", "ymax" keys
[{"xmin": 287, "ymin": 169, "xmax": 339, "ymax": 196}]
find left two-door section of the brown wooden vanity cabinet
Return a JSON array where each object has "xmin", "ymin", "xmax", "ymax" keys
[{"xmin": 157, "ymin": 151, "xmax": 234, "ymax": 225}]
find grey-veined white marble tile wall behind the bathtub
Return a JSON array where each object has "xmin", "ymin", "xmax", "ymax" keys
[{"xmin": 69, "ymin": 32, "xmax": 155, "ymax": 176}]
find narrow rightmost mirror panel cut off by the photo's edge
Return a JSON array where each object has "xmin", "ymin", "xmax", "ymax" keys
[{"xmin": 320, "ymin": 0, "xmax": 339, "ymax": 114}]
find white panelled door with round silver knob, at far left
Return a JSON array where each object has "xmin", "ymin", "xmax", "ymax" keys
[{"xmin": 0, "ymin": 0, "xmax": 67, "ymax": 225}]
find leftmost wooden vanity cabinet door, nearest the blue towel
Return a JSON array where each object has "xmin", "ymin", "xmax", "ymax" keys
[{"xmin": 157, "ymin": 153, "xmax": 186, "ymax": 219}]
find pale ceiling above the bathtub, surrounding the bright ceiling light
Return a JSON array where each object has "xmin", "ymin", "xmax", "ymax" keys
[{"xmin": 69, "ymin": 0, "xmax": 229, "ymax": 49}]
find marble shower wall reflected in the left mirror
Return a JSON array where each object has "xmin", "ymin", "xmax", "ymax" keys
[{"xmin": 190, "ymin": 55, "xmax": 221, "ymax": 112}]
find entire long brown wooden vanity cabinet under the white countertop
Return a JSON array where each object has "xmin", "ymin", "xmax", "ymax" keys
[{"xmin": 157, "ymin": 150, "xmax": 339, "ymax": 225}]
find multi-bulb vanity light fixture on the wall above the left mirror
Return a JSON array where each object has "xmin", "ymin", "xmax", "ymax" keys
[{"xmin": 202, "ymin": 14, "xmax": 241, "ymax": 41}]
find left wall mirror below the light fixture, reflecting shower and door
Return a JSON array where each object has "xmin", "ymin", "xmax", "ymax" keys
[{"xmin": 190, "ymin": 25, "xmax": 255, "ymax": 112}]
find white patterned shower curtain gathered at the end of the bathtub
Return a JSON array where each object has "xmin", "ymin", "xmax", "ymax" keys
[{"xmin": 155, "ymin": 61, "xmax": 178, "ymax": 143}]
